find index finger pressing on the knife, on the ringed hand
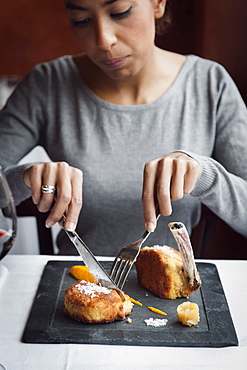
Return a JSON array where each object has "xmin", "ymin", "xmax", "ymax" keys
[{"xmin": 61, "ymin": 168, "xmax": 82, "ymax": 231}]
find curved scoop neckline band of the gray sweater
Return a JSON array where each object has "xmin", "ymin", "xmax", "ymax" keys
[{"xmin": 62, "ymin": 55, "xmax": 193, "ymax": 111}]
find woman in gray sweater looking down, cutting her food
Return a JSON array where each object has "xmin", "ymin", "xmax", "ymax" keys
[{"xmin": 0, "ymin": 0, "xmax": 247, "ymax": 255}]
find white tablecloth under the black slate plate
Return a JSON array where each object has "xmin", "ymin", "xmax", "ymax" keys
[{"xmin": 0, "ymin": 255, "xmax": 247, "ymax": 370}]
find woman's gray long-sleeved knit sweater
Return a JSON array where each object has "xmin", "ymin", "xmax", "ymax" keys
[{"xmin": 0, "ymin": 55, "xmax": 247, "ymax": 255}]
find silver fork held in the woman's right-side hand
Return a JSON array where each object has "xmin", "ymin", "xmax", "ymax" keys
[{"xmin": 110, "ymin": 214, "xmax": 160, "ymax": 290}]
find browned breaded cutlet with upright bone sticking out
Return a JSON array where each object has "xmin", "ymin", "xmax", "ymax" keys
[{"xmin": 136, "ymin": 223, "xmax": 201, "ymax": 299}]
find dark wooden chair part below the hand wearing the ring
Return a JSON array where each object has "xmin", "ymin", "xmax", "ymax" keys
[{"xmin": 16, "ymin": 198, "xmax": 54, "ymax": 254}]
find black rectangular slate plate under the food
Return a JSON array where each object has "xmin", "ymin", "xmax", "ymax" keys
[{"xmin": 23, "ymin": 261, "xmax": 238, "ymax": 347}]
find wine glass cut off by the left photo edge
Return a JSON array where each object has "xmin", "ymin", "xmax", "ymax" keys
[{"xmin": 0, "ymin": 166, "xmax": 17, "ymax": 260}]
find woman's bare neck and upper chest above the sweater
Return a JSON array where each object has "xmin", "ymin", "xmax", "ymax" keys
[{"xmin": 74, "ymin": 47, "xmax": 186, "ymax": 105}]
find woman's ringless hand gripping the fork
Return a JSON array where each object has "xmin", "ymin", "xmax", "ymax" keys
[{"xmin": 142, "ymin": 152, "xmax": 201, "ymax": 231}]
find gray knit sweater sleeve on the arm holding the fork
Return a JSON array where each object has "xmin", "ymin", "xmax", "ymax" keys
[{"xmin": 184, "ymin": 67, "xmax": 247, "ymax": 237}]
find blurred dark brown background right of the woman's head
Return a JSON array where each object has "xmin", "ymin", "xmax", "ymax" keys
[{"xmin": 158, "ymin": 0, "xmax": 247, "ymax": 103}]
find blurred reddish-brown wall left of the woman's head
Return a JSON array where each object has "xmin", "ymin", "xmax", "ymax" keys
[{"xmin": 0, "ymin": 0, "xmax": 79, "ymax": 76}]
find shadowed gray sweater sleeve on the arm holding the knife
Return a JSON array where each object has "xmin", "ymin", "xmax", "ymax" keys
[{"xmin": 0, "ymin": 67, "xmax": 46, "ymax": 204}]
